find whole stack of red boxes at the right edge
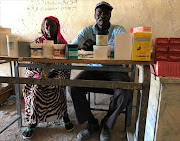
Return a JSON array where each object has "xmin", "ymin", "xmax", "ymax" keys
[{"xmin": 151, "ymin": 38, "xmax": 180, "ymax": 77}]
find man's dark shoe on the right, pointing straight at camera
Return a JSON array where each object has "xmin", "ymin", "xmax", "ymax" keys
[{"xmin": 100, "ymin": 127, "xmax": 111, "ymax": 141}]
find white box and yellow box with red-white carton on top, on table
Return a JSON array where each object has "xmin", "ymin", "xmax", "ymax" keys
[{"xmin": 114, "ymin": 26, "xmax": 152, "ymax": 61}]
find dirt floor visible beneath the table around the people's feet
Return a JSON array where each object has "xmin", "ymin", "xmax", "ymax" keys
[{"xmin": 0, "ymin": 98, "xmax": 126, "ymax": 141}]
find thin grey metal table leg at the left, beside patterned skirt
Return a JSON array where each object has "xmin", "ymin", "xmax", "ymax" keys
[{"xmin": 14, "ymin": 61, "xmax": 22, "ymax": 127}]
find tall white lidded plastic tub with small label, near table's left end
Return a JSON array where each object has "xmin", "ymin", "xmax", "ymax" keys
[{"xmin": 6, "ymin": 34, "xmax": 19, "ymax": 57}]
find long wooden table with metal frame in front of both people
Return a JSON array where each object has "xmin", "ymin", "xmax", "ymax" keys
[{"xmin": 0, "ymin": 57, "xmax": 154, "ymax": 141}]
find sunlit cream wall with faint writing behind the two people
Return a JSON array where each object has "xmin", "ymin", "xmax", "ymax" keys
[{"xmin": 0, "ymin": 0, "xmax": 180, "ymax": 43}]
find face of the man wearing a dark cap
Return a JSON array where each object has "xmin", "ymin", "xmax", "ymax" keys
[{"xmin": 94, "ymin": 7, "xmax": 111, "ymax": 27}]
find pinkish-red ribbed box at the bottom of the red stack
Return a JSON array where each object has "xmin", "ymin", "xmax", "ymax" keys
[{"xmin": 150, "ymin": 61, "xmax": 180, "ymax": 77}]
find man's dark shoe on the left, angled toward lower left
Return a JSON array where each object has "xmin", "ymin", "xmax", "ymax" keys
[{"xmin": 77, "ymin": 120, "xmax": 100, "ymax": 141}]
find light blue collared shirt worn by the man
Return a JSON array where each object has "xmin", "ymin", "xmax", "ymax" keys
[{"xmin": 71, "ymin": 24, "xmax": 126, "ymax": 46}]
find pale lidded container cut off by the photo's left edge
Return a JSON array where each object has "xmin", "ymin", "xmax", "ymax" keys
[{"xmin": 0, "ymin": 28, "xmax": 11, "ymax": 56}]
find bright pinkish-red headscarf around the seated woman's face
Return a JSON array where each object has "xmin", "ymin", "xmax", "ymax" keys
[{"xmin": 37, "ymin": 16, "xmax": 67, "ymax": 44}]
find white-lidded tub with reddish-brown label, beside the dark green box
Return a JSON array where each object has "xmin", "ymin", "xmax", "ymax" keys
[{"xmin": 54, "ymin": 44, "xmax": 66, "ymax": 59}]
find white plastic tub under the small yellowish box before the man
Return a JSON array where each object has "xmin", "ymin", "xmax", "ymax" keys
[{"xmin": 93, "ymin": 45, "xmax": 111, "ymax": 60}]
